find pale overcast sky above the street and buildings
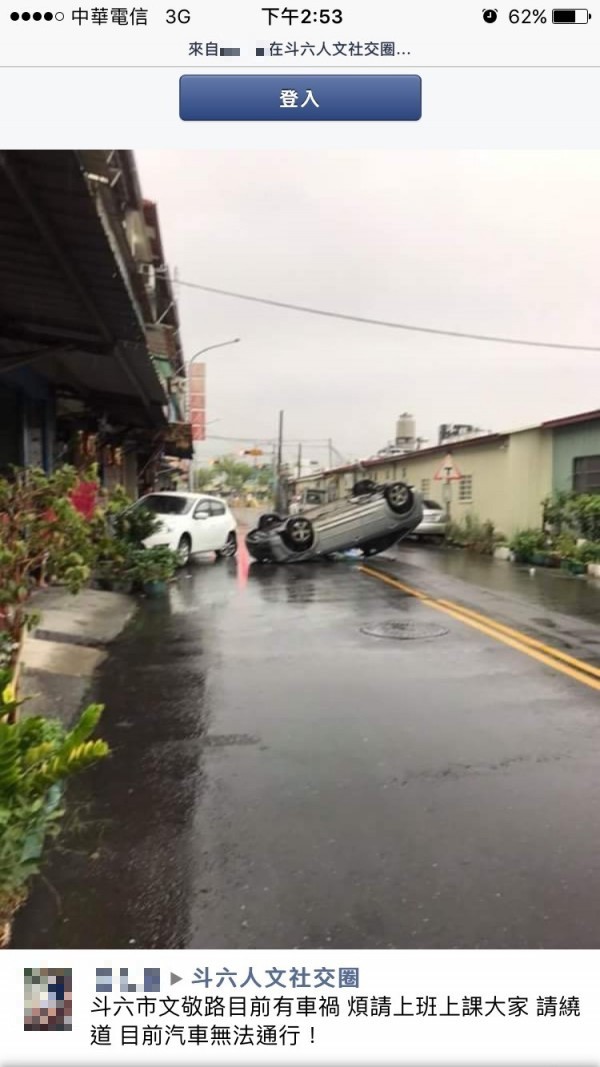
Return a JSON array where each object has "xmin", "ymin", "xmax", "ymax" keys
[{"xmin": 137, "ymin": 150, "xmax": 600, "ymax": 469}]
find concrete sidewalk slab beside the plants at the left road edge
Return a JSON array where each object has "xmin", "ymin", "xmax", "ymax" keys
[{"xmin": 20, "ymin": 588, "xmax": 137, "ymax": 722}]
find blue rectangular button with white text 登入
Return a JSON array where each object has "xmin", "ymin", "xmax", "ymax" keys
[{"xmin": 179, "ymin": 74, "xmax": 421, "ymax": 123}]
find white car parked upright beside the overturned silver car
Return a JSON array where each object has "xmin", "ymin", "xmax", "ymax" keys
[{"xmin": 135, "ymin": 491, "xmax": 237, "ymax": 566}]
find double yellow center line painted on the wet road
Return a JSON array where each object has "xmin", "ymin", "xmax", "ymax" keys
[{"xmin": 359, "ymin": 564, "xmax": 600, "ymax": 690}]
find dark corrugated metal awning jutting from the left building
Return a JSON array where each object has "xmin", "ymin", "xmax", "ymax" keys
[{"xmin": 0, "ymin": 152, "xmax": 167, "ymax": 426}]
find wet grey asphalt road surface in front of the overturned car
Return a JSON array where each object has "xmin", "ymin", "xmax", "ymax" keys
[{"xmin": 14, "ymin": 548, "xmax": 600, "ymax": 949}]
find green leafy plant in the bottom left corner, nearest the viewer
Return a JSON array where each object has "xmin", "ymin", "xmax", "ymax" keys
[{"xmin": 0, "ymin": 704, "xmax": 109, "ymax": 927}]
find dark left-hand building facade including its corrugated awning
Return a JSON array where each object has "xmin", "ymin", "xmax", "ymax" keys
[{"xmin": 0, "ymin": 152, "xmax": 190, "ymax": 495}]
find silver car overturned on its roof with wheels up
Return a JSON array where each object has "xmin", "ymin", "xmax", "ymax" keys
[{"xmin": 246, "ymin": 480, "xmax": 423, "ymax": 563}]
